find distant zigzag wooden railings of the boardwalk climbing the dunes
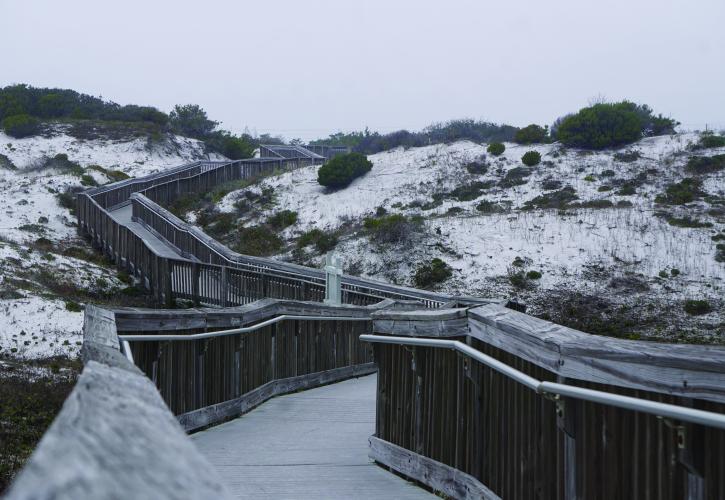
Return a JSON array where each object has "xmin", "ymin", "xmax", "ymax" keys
[{"xmin": 77, "ymin": 158, "xmax": 486, "ymax": 307}]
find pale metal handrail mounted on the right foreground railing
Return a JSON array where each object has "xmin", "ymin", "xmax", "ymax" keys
[{"xmin": 360, "ymin": 335, "xmax": 725, "ymax": 430}]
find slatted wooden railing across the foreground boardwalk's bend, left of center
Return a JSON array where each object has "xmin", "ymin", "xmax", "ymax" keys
[{"xmin": 109, "ymin": 299, "xmax": 420, "ymax": 430}]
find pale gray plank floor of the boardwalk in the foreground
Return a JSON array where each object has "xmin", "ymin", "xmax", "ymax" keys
[{"xmin": 191, "ymin": 375, "xmax": 436, "ymax": 500}]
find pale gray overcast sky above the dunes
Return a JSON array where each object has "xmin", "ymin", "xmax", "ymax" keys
[{"xmin": 0, "ymin": 0, "xmax": 725, "ymax": 139}]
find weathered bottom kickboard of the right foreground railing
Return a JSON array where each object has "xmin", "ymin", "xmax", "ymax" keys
[{"xmin": 370, "ymin": 436, "xmax": 499, "ymax": 500}]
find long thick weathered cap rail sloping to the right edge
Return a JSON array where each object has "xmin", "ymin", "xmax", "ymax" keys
[{"xmin": 469, "ymin": 305, "xmax": 725, "ymax": 402}]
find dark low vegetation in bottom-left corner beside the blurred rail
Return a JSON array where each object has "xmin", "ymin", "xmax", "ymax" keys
[{"xmin": 0, "ymin": 358, "xmax": 81, "ymax": 494}]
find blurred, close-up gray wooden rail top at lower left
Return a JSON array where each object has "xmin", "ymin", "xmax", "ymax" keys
[{"xmin": 4, "ymin": 306, "xmax": 230, "ymax": 500}]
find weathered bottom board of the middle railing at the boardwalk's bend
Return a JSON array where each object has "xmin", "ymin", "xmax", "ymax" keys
[{"xmin": 176, "ymin": 363, "xmax": 377, "ymax": 432}]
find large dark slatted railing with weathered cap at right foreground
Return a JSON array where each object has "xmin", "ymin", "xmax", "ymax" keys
[{"xmin": 365, "ymin": 304, "xmax": 725, "ymax": 499}]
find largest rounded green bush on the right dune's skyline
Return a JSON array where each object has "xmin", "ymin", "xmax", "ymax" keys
[{"xmin": 555, "ymin": 101, "xmax": 678, "ymax": 149}]
